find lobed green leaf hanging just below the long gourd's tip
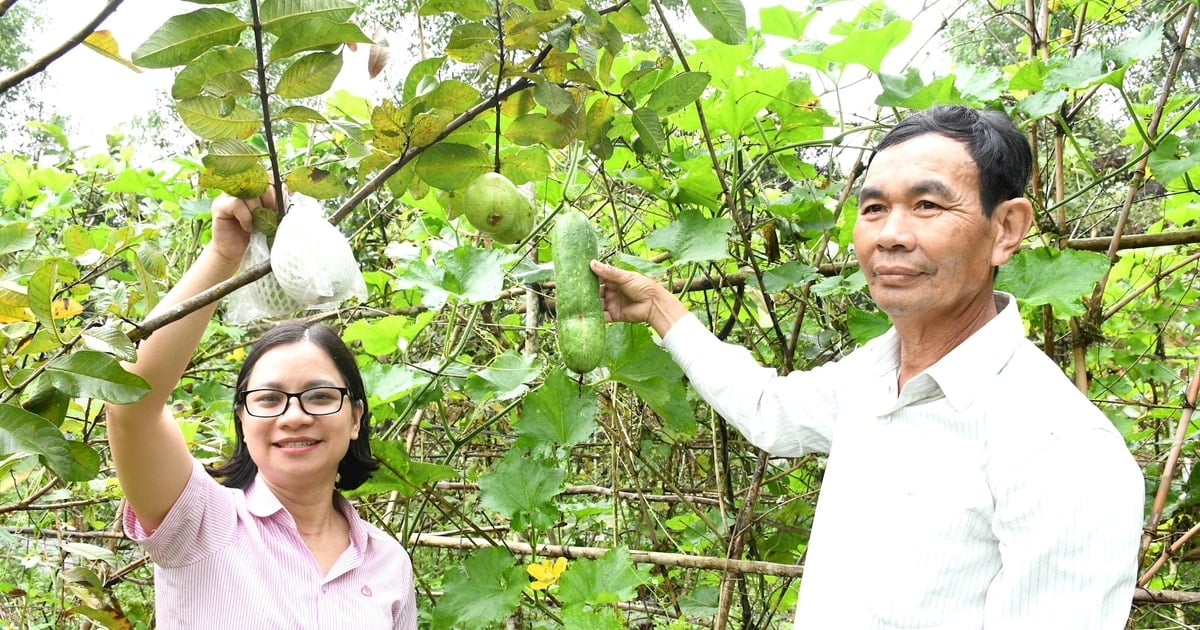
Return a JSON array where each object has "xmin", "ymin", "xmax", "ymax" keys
[{"xmin": 517, "ymin": 370, "xmax": 600, "ymax": 448}]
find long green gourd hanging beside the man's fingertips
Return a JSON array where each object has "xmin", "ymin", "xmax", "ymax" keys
[{"xmin": 553, "ymin": 210, "xmax": 605, "ymax": 374}]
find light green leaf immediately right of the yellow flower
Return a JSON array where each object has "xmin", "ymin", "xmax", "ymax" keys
[{"xmin": 556, "ymin": 546, "xmax": 649, "ymax": 607}]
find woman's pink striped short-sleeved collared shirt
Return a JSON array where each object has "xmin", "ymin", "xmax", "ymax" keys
[{"xmin": 125, "ymin": 462, "xmax": 416, "ymax": 630}]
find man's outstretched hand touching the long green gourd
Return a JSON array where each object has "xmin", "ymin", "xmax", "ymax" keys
[{"xmin": 592, "ymin": 260, "xmax": 688, "ymax": 336}]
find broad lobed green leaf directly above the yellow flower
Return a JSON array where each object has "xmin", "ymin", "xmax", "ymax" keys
[{"xmin": 479, "ymin": 449, "xmax": 566, "ymax": 530}]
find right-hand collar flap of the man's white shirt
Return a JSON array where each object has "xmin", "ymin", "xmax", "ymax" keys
[{"xmin": 925, "ymin": 292, "xmax": 1025, "ymax": 412}]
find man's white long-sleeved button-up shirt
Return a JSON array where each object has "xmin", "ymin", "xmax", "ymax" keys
[{"xmin": 662, "ymin": 293, "xmax": 1145, "ymax": 630}]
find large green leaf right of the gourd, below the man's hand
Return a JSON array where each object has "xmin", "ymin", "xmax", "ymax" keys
[{"xmin": 605, "ymin": 324, "xmax": 696, "ymax": 438}]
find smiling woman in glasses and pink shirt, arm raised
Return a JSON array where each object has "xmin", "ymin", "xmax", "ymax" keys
[{"xmin": 107, "ymin": 192, "xmax": 416, "ymax": 630}]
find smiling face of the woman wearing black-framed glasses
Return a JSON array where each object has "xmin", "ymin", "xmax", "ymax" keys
[{"xmin": 239, "ymin": 341, "xmax": 362, "ymax": 493}]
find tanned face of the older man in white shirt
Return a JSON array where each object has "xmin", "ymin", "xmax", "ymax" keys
[{"xmin": 854, "ymin": 133, "xmax": 1012, "ymax": 325}]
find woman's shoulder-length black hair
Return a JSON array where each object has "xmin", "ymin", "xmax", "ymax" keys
[{"xmin": 209, "ymin": 320, "xmax": 379, "ymax": 490}]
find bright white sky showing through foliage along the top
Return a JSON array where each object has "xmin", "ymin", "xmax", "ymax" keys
[{"xmin": 21, "ymin": 0, "xmax": 942, "ymax": 156}]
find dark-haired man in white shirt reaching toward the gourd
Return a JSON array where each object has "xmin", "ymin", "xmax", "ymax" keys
[{"xmin": 593, "ymin": 107, "xmax": 1144, "ymax": 630}]
